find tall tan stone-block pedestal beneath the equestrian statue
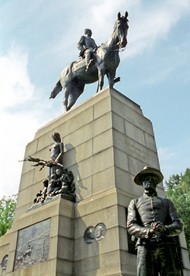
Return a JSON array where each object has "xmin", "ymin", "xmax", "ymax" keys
[{"xmin": 0, "ymin": 89, "xmax": 190, "ymax": 276}]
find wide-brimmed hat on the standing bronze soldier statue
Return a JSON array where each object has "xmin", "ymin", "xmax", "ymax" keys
[{"xmin": 134, "ymin": 166, "xmax": 164, "ymax": 185}]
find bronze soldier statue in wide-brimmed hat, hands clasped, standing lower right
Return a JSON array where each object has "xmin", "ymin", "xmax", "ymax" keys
[{"xmin": 127, "ymin": 166, "xmax": 183, "ymax": 276}]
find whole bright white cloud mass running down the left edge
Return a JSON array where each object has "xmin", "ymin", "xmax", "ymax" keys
[{"xmin": 0, "ymin": 47, "xmax": 42, "ymax": 197}]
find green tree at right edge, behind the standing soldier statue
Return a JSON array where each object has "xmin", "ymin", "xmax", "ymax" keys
[{"xmin": 166, "ymin": 168, "xmax": 190, "ymax": 255}]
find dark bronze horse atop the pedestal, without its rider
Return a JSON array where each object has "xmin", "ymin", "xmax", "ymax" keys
[{"xmin": 50, "ymin": 12, "xmax": 129, "ymax": 111}]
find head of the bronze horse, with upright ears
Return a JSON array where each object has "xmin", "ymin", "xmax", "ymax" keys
[{"xmin": 114, "ymin": 12, "xmax": 129, "ymax": 48}]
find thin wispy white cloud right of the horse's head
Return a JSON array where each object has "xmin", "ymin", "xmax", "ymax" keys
[{"xmin": 125, "ymin": 0, "xmax": 190, "ymax": 57}]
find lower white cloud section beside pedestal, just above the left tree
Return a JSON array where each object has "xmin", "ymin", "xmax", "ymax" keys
[{"xmin": 0, "ymin": 112, "xmax": 38, "ymax": 197}]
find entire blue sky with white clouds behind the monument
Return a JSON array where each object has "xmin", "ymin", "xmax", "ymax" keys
[{"xmin": 0, "ymin": 0, "xmax": 190, "ymax": 197}]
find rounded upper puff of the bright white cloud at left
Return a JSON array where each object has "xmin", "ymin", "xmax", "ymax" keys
[{"xmin": 0, "ymin": 46, "xmax": 34, "ymax": 109}]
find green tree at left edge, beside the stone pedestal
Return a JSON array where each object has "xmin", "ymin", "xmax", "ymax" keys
[{"xmin": 0, "ymin": 195, "xmax": 17, "ymax": 236}]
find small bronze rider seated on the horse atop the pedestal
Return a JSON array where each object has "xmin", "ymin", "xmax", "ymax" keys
[{"xmin": 77, "ymin": 29, "xmax": 97, "ymax": 71}]
